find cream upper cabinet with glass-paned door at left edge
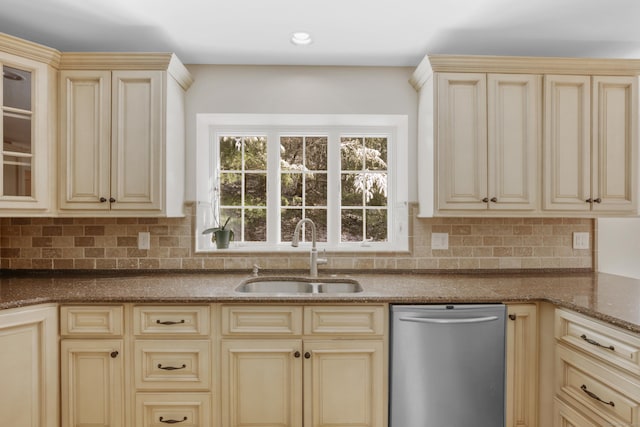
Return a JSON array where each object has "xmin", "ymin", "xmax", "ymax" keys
[{"xmin": 0, "ymin": 34, "xmax": 60, "ymax": 216}]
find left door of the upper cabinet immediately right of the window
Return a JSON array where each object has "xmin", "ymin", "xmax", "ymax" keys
[{"xmin": 436, "ymin": 73, "xmax": 488, "ymax": 210}]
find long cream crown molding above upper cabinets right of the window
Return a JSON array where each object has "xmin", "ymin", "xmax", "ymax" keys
[{"xmin": 410, "ymin": 55, "xmax": 640, "ymax": 89}]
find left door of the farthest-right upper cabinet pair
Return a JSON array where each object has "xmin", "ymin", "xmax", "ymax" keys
[{"xmin": 542, "ymin": 75, "xmax": 591, "ymax": 211}]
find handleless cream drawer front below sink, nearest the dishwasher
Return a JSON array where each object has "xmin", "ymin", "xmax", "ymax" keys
[{"xmin": 304, "ymin": 305, "xmax": 385, "ymax": 336}]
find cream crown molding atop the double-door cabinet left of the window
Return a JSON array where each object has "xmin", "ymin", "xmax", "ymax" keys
[{"xmin": 59, "ymin": 52, "xmax": 193, "ymax": 90}]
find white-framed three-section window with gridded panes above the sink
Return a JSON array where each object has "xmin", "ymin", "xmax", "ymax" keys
[{"xmin": 196, "ymin": 114, "xmax": 408, "ymax": 252}]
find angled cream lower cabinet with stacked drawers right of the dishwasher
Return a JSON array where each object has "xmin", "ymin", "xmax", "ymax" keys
[{"xmin": 554, "ymin": 309, "xmax": 640, "ymax": 427}]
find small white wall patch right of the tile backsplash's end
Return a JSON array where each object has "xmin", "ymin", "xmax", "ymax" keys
[{"xmin": 597, "ymin": 218, "xmax": 640, "ymax": 279}]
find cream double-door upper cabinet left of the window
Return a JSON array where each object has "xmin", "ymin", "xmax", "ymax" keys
[{"xmin": 59, "ymin": 54, "xmax": 191, "ymax": 216}]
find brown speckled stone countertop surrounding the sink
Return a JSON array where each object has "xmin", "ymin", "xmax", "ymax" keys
[{"xmin": 0, "ymin": 271, "xmax": 640, "ymax": 333}]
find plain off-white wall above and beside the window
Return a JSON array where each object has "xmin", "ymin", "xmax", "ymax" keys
[{"xmin": 186, "ymin": 65, "xmax": 418, "ymax": 201}]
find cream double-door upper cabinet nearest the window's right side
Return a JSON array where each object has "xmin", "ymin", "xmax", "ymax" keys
[{"xmin": 436, "ymin": 73, "xmax": 541, "ymax": 214}]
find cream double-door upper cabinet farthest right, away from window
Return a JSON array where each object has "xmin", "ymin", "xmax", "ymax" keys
[{"xmin": 543, "ymin": 75, "xmax": 638, "ymax": 213}]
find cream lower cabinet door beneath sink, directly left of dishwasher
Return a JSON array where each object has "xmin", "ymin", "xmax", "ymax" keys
[{"xmin": 304, "ymin": 340, "xmax": 387, "ymax": 427}]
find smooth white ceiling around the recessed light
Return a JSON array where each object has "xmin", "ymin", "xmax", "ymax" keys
[{"xmin": 0, "ymin": 0, "xmax": 640, "ymax": 66}]
